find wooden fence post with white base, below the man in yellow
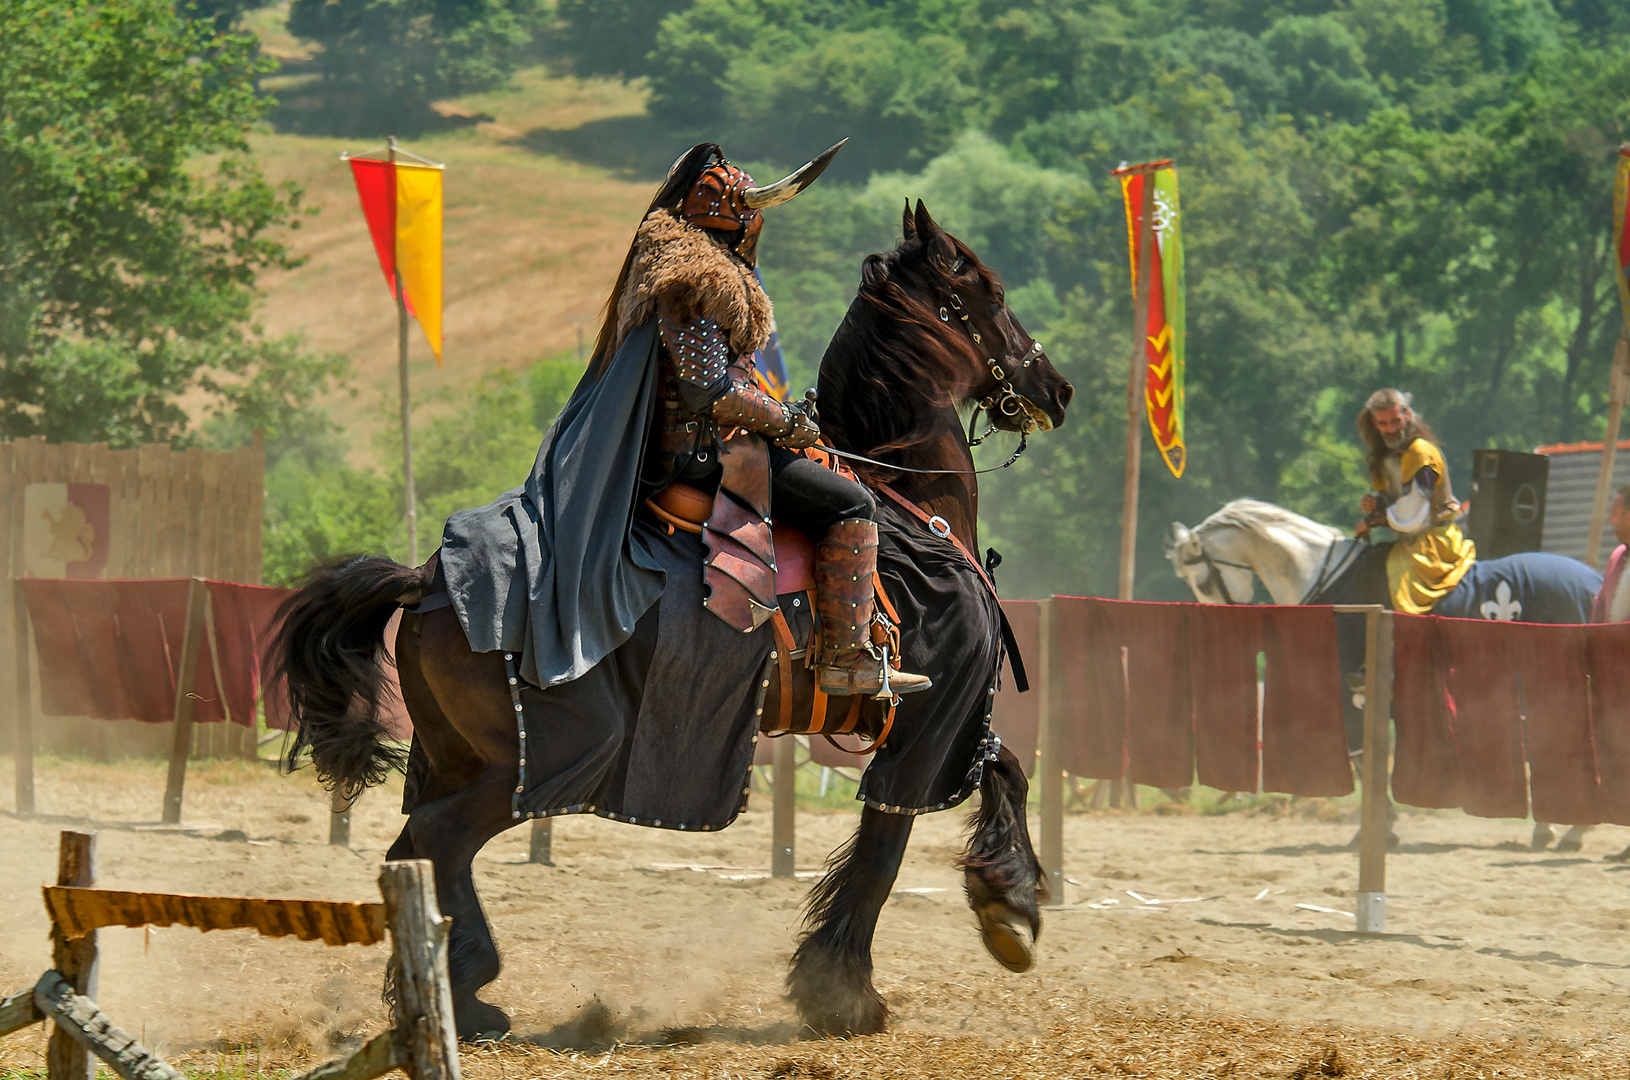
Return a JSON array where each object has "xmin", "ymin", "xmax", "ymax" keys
[{"xmin": 1356, "ymin": 608, "xmax": 1392, "ymax": 933}]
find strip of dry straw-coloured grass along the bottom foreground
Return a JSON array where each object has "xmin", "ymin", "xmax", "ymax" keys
[{"xmin": 123, "ymin": 1000, "xmax": 1625, "ymax": 1080}]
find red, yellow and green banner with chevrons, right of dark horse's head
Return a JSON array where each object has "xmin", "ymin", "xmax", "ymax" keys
[{"xmin": 1113, "ymin": 161, "xmax": 1188, "ymax": 476}]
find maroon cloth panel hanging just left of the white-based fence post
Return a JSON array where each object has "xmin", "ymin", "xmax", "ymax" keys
[{"xmin": 1258, "ymin": 608, "xmax": 1353, "ymax": 798}]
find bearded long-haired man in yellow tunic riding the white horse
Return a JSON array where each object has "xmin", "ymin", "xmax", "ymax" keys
[{"xmin": 1356, "ymin": 388, "xmax": 1477, "ymax": 614}]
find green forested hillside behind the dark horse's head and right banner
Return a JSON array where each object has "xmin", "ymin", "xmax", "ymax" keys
[{"xmin": 561, "ymin": 0, "xmax": 1630, "ymax": 596}]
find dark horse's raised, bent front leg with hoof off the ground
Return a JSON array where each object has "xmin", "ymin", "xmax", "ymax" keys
[{"xmin": 960, "ymin": 746, "xmax": 1046, "ymax": 971}]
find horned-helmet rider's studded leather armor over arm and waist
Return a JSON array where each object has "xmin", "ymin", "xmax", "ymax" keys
[{"xmin": 647, "ymin": 305, "xmax": 818, "ymax": 479}]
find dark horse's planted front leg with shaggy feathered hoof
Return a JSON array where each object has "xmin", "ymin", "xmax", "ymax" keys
[{"xmin": 787, "ymin": 806, "xmax": 913, "ymax": 1034}]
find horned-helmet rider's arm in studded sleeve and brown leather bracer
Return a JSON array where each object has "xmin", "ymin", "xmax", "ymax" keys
[{"xmin": 657, "ymin": 306, "xmax": 820, "ymax": 446}]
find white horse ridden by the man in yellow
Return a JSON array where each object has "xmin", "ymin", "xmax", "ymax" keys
[{"xmin": 1165, "ymin": 498, "xmax": 1597, "ymax": 855}]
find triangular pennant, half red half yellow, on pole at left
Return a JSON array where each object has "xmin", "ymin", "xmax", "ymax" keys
[{"xmin": 349, "ymin": 158, "xmax": 442, "ymax": 367}]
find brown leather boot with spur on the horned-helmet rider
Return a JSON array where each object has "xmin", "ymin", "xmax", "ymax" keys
[{"xmin": 815, "ymin": 518, "xmax": 934, "ymax": 697}]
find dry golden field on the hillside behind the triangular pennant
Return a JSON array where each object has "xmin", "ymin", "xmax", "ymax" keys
[{"xmin": 241, "ymin": 8, "xmax": 661, "ymax": 463}]
